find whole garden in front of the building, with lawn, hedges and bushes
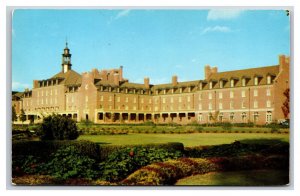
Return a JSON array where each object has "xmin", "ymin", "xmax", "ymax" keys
[{"xmin": 12, "ymin": 117, "xmax": 289, "ymax": 186}]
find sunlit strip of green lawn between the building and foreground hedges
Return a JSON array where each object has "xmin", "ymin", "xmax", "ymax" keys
[{"xmin": 78, "ymin": 133, "xmax": 289, "ymax": 146}]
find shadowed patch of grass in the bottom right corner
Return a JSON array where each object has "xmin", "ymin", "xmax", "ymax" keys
[{"xmin": 176, "ymin": 170, "xmax": 289, "ymax": 186}]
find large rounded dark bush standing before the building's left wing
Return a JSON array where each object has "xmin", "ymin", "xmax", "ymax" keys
[{"xmin": 38, "ymin": 114, "xmax": 79, "ymax": 140}]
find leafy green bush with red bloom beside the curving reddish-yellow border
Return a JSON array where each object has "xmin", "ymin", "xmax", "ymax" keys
[{"xmin": 99, "ymin": 147, "xmax": 182, "ymax": 182}]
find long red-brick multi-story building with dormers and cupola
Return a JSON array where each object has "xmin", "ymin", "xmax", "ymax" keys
[{"xmin": 12, "ymin": 44, "xmax": 290, "ymax": 124}]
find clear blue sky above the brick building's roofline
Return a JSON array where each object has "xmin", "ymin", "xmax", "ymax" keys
[{"xmin": 12, "ymin": 9, "xmax": 290, "ymax": 91}]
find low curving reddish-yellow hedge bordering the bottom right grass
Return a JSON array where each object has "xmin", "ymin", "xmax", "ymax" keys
[{"xmin": 120, "ymin": 155, "xmax": 289, "ymax": 186}]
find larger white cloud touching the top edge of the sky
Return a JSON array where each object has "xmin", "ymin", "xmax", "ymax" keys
[{"xmin": 207, "ymin": 10, "xmax": 244, "ymax": 20}]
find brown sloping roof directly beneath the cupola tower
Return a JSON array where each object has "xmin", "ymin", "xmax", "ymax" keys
[{"xmin": 51, "ymin": 70, "xmax": 81, "ymax": 85}]
